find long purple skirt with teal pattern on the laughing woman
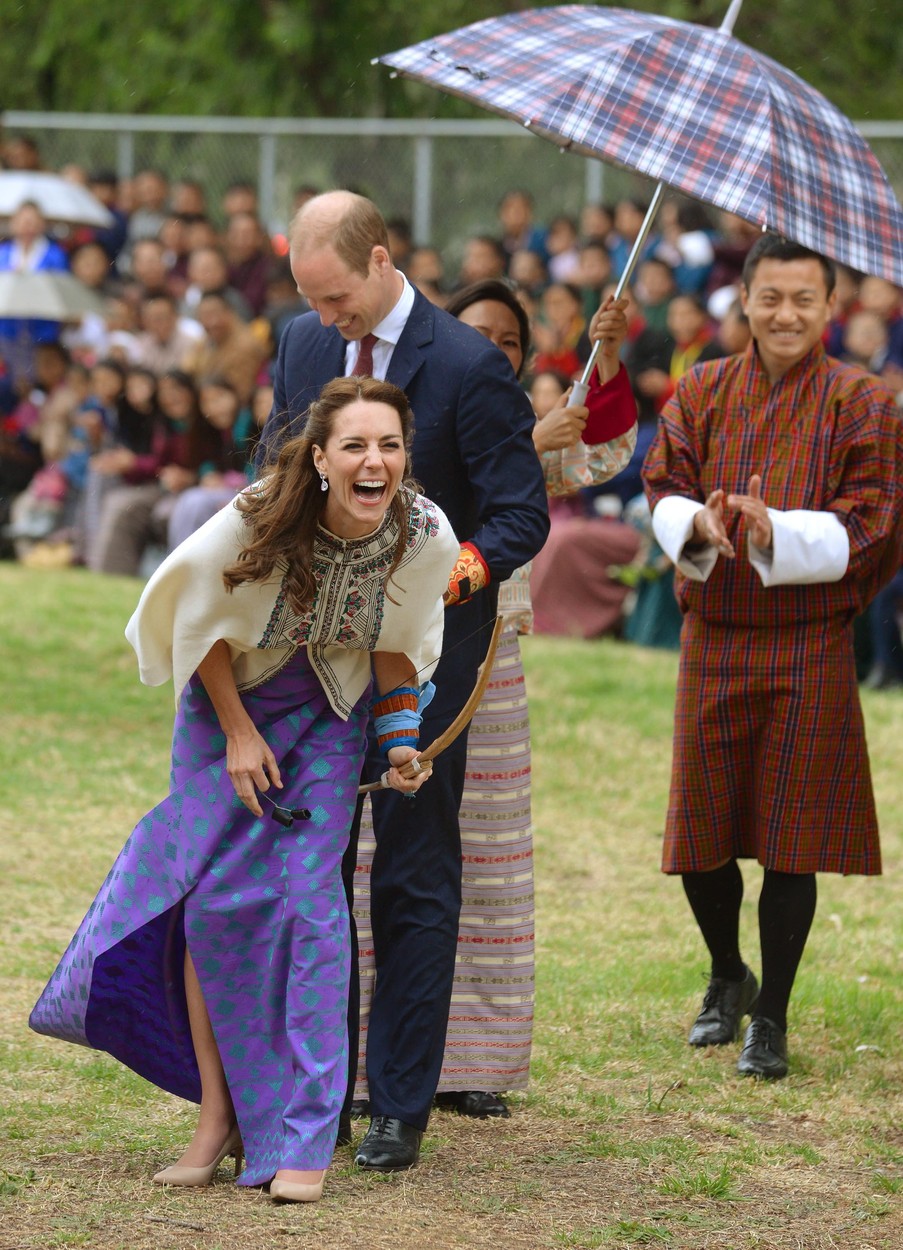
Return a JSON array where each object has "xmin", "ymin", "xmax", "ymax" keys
[{"xmin": 30, "ymin": 650, "xmax": 366, "ymax": 1185}]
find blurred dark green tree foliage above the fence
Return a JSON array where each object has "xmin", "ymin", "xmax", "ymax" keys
[{"xmin": 0, "ymin": 0, "xmax": 903, "ymax": 119}]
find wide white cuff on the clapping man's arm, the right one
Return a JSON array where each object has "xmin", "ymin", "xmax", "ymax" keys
[{"xmin": 748, "ymin": 508, "xmax": 849, "ymax": 586}]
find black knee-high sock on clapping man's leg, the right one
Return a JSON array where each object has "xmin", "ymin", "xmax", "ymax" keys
[{"xmin": 755, "ymin": 869, "xmax": 817, "ymax": 1031}]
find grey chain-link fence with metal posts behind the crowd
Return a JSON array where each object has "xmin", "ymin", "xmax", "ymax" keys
[{"xmin": 3, "ymin": 113, "xmax": 903, "ymax": 264}]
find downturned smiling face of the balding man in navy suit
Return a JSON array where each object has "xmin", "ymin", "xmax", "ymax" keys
[{"xmin": 291, "ymin": 245, "xmax": 401, "ymax": 341}]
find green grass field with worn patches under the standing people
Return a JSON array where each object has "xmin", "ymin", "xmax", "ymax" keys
[{"xmin": 0, "ymin": 565, "xmax": 903, "ymax": 1250}]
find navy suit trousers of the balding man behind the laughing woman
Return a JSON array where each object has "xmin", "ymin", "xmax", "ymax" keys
[{"xmin": 343, "ymin": 595, "xmax": 494, "ymax": 1130}]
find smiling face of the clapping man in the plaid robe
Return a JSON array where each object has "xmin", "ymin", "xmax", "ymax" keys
[{"xmin": 740, "ymin": 258, "xmax": 834, "ymax": 383}]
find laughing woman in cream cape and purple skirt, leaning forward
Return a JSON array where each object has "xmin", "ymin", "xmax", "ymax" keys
[{"xmin": 30, "ymin": 378, "xmax": 459, "ymax": 1201}]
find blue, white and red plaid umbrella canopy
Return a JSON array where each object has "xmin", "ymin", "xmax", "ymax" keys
[{"xmin": 378, "ymin": 0, "xmax": 903, "ymax": 285}]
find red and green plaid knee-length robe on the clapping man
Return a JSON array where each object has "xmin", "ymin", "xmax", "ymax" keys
[{"xmin": 643, "ymin": 344, "xmax": 903, "ymax": 874}]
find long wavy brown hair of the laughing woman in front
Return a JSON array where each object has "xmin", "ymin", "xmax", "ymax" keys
[{"xmin": 223, "ymin": 378, "xmax": 416, "ymax": 611}]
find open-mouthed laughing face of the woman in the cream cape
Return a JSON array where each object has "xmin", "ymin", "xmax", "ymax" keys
[{"xmin": 313, "ymin": 400, "xmax": 408, "ymax": 539}]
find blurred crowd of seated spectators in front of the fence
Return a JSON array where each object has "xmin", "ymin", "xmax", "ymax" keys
[{"xmin": 0, "ymin": 136, "xmax": 903, "ymax": 686}]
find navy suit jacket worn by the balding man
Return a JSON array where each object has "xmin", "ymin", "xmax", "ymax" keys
[{"xmin": 258, "ymin": 291, "xmax": 549, "ymax": 587}]
